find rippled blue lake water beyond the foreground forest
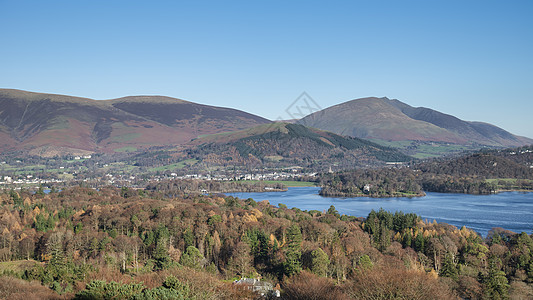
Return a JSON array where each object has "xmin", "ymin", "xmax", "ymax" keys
[{"xmin": 227, "ymin": 187, "xmax": 533, "ymax": 236}]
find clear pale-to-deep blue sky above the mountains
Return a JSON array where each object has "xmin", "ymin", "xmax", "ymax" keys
[{"xmin": 0, "ymin": 0, "xmax": 533, "ymax": 138}]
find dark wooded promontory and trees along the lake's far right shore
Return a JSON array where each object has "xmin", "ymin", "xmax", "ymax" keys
[{"xmin": 320, "ymin": 152, "xmax": 533, "ymax": 197}]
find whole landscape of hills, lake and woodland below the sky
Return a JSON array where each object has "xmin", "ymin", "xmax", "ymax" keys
[{"xmin": 0, "ymin": 90, "xmax": 533, "ymax": 299}]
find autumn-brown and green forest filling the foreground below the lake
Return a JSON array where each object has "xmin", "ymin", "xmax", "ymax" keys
[{"xmin": 0, "ymin": 186, "xmax": 533, "ymax": 299}]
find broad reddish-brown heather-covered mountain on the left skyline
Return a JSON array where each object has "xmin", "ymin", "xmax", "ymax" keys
[{"xmin": 0, "ymin": 89, "xmax": 270, "ymax": 156}]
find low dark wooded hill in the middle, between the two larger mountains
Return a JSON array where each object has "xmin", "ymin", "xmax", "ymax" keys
[{"xmin": 180, "ymin": 123, "xmax": 412, "ymax": 170}]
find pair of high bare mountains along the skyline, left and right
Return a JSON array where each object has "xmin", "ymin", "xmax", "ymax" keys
[{"xmin": 0, "ymin": 89, "xmax": 533, "ymax": 156}]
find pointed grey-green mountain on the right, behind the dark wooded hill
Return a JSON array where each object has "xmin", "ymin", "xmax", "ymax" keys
[{"xmin": 298, "ymin": 97, "xmax": 533, "ymax": 155}]
